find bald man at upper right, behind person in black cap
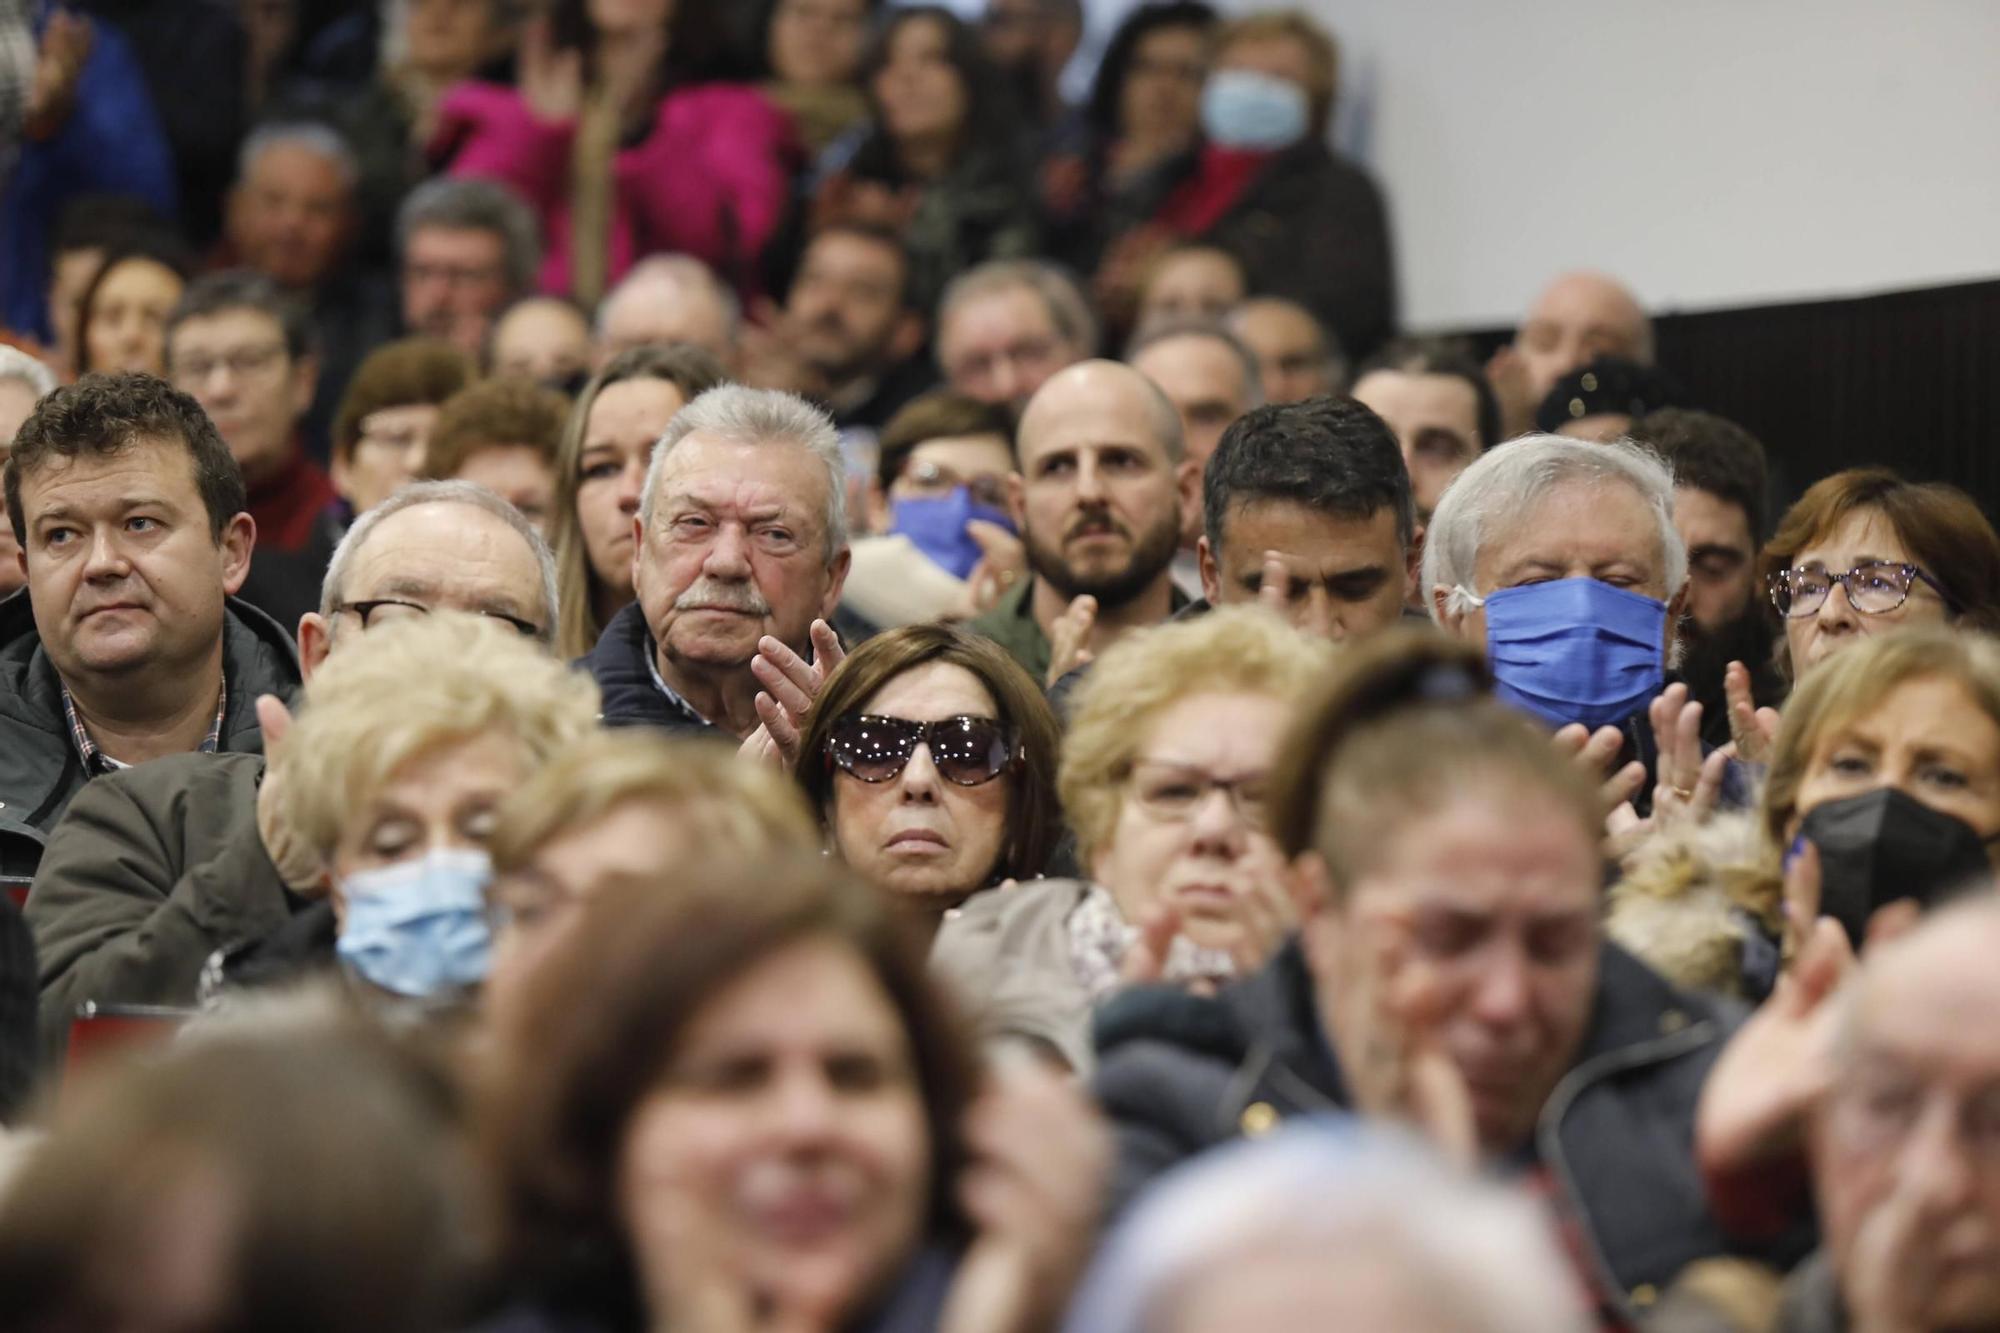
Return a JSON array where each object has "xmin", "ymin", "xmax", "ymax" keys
[{"xmin": 1486, "ymin": 270, "xmax": 1652, "ymax": 438}]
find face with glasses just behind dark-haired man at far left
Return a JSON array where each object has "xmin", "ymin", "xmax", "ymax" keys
[{"xmin": 166, "ymin": 306, "xmax": 320, "ymax": 486}]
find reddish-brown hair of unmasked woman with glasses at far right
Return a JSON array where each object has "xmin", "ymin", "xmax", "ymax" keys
[{"xmin": 1758, "ymin": 468, "xmax": 2000, "ymax": 632}]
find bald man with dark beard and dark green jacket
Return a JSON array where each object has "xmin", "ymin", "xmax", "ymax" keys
[{"xmin": 968, "ymin": 360, "xmax": 1200, "ymax": 683}]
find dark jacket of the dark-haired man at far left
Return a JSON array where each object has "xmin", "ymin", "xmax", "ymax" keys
[{"xmin": 0, "ymin": 590, "xmax": 300, "ymax": 875}]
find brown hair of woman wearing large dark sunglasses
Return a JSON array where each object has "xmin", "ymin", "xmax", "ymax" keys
[{"xmin": 798, "ymin": 624, "xmax": 1062, "ymax": 879}]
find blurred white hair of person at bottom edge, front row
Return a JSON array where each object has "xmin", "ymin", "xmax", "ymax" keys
[{"xmin": 1064, "ymin": 1119, "xmax": 1588, "ymax": 1333}]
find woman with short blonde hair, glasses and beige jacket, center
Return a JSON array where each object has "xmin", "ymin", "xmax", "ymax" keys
[{"xmin": 932, "ymin": 608, "xmax": 1332, "ymax": 1071}]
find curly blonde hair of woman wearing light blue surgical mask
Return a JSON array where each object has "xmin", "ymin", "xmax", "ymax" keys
[{"xmin": 270, "ymin": 610, "xmax": 598, "ymax": 859}]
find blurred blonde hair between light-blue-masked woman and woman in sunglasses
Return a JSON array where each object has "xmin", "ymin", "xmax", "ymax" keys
[{"xmin": 492, "ymin": 731, "xmax": 820, "ymax": 875}]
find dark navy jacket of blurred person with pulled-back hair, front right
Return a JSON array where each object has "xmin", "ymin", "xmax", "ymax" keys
[{"xmin": 1096, "ymin": 943, "xmax": 1804, "ymax": 1323}]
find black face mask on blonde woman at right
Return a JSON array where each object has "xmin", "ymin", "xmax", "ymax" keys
[{"xmin": 1798, "ymin": 787, "xmax": 1994, "ymax": 949}]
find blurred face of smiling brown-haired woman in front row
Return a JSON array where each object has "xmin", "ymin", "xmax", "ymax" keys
[{"xmin": 618, "ymin": 937, "xmax": 932, "ymax": 1323}]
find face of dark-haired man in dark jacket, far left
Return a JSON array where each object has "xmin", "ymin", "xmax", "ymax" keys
[{"xmin": 20, "ymin": 440, "xmax": 252, "ymax": 687}]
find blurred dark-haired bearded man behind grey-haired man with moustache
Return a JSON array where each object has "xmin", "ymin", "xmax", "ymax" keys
[{"xmin": 742, "ymin": 226, "xmax": 936, "ymax": 430}]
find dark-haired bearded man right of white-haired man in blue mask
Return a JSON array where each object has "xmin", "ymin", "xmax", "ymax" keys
[{"xmin": 1630, "ymin": 408, "xmax": 1784, "ymax": 747}]
